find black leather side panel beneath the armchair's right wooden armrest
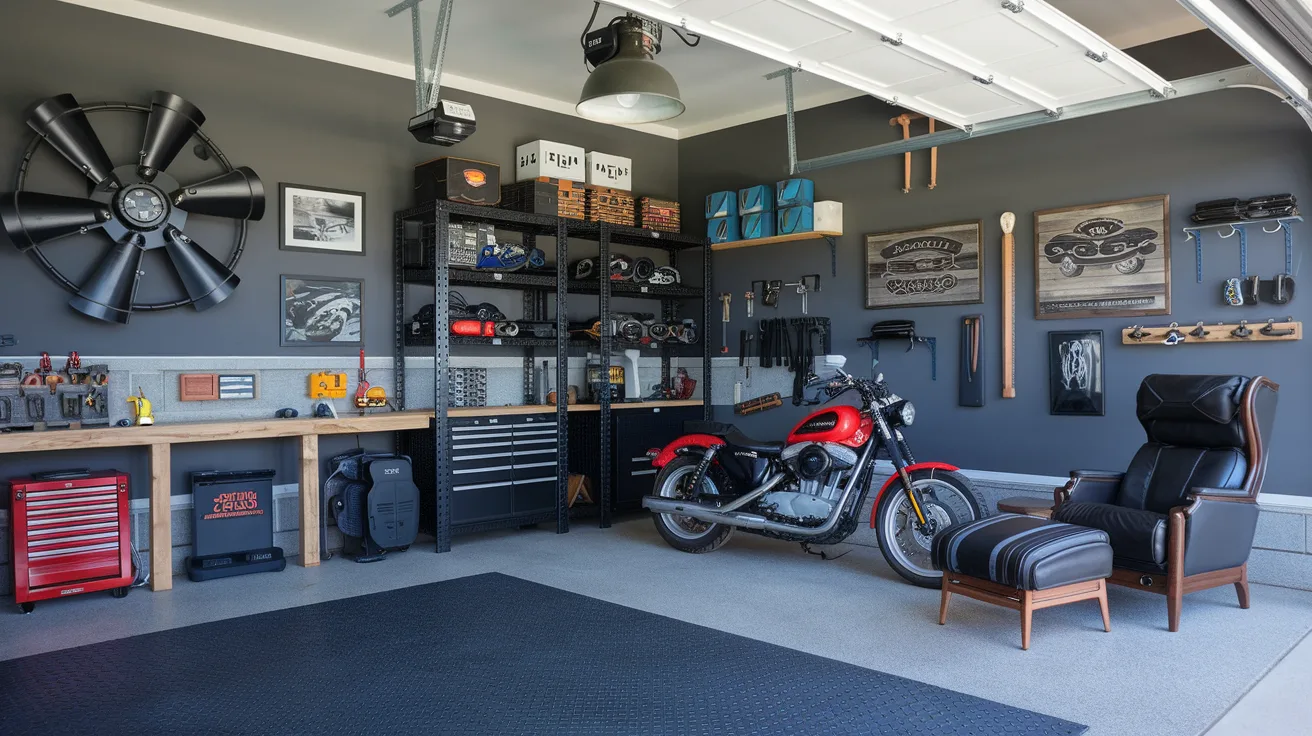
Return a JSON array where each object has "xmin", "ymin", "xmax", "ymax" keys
[{"xmin": 1172, "ymin": 488, "xmax": 1260, "ymax": 575}]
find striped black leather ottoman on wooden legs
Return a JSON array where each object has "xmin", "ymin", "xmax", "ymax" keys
[{"xmin": 932, "ymin": 514, "xmax": 1111, "ymax": 649}]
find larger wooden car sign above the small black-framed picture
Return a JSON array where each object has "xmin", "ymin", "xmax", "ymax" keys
[{"xmin": 1034, "ymin": 194, "xmax": 1170, "ymax": 319}]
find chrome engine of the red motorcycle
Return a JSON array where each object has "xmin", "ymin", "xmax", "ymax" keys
[{"xmin": 760, "ymin": 442, "xmax": 858, "ymax": 526}]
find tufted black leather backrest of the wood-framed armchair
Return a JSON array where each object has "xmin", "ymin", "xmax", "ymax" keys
[{"xmin": 1117, "ymin": 374, "xmax": 1279, "ymax": 513}]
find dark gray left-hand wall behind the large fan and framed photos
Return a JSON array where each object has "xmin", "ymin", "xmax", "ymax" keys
[{"xmin": 0, "ymin": 0, "xmax": 678, "ymax": 505}]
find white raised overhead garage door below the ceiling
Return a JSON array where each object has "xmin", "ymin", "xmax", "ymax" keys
[{"xmin": 607, "ymin": 0, "xmax": 1169, "ymax": 127}]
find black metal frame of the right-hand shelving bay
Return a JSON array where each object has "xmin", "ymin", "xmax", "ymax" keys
[{"xmin": 569, "ymin": 220, "xmax": 711, "ymax": 527}]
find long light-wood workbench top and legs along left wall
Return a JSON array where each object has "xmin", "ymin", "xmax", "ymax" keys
[{"xmin": 0, "ymin": 400, "xmax": 702, "ymax": 590}]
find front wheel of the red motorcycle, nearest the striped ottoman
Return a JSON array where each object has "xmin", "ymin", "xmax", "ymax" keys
[{"xmin": 875, "ymin": 468, "xmax": 988, "ymax": 588}]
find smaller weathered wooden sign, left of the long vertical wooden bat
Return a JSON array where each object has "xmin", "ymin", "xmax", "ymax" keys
[{"xmin": 866, "ymin": 220, "xmax": 984, "ymax": 310}]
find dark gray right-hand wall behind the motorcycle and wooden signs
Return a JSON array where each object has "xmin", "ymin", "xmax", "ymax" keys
[{"xmin": 680, "ymin": 34, "xmax": 1312, "ymax": 495}]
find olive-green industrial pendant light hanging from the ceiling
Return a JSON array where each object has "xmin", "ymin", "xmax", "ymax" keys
[{"xmin": 576, "ymin": 14, "xmax": 685, "ymax": 125}]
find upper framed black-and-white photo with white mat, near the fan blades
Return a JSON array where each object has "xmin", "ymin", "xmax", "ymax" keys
[{"xmin": 278, "ymin": 182, "xmax": 365, "ymax": 256}]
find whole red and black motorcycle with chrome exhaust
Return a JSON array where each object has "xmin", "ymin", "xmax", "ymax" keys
[{"xmin": 643, "ymin": 369, "xmax": 987, "ymax": 588}]
